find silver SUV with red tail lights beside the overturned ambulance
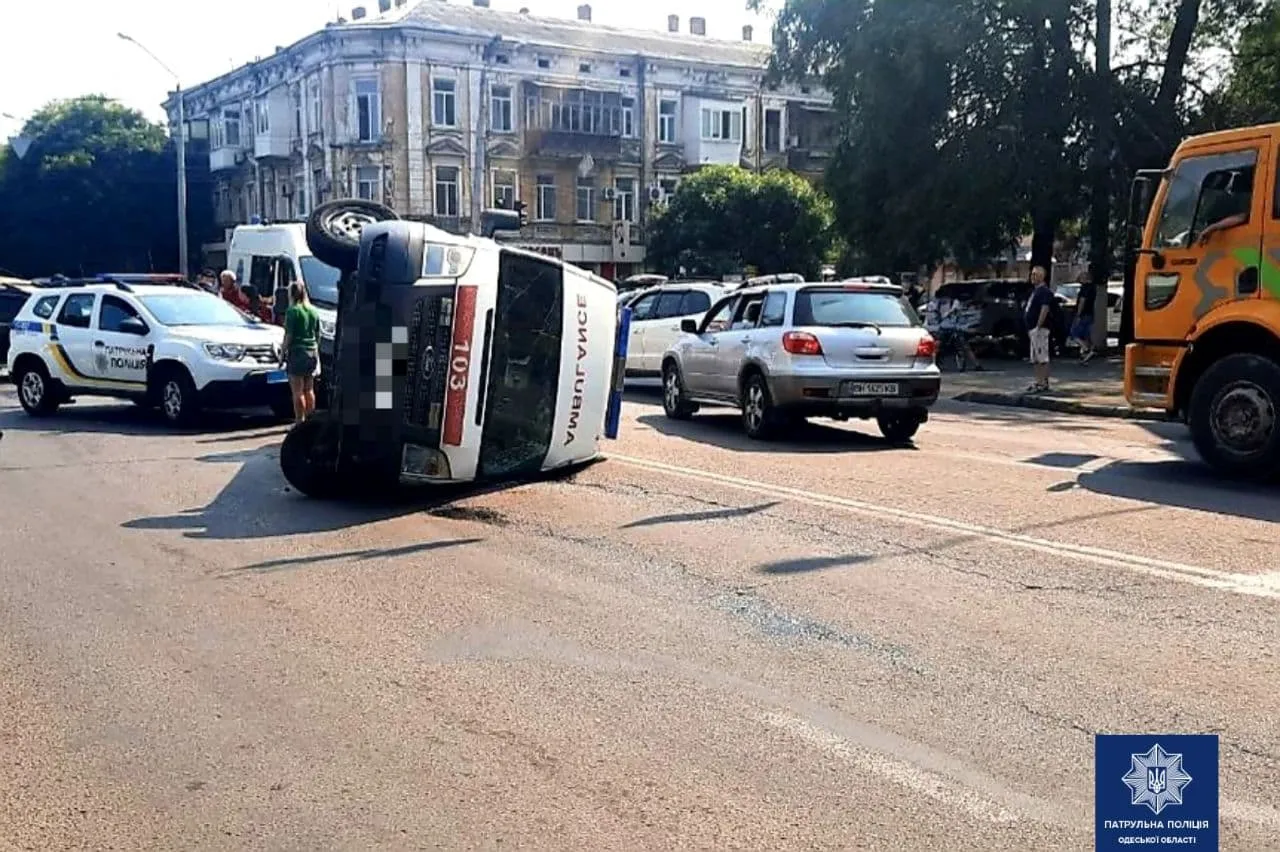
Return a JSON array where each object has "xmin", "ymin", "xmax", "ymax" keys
[{"xmin": 662, "ymin": 281, "xmax": 942, "ymax": 444}]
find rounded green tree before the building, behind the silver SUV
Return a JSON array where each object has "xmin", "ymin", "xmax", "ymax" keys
[{"xmin": 649, "ymin": 166, "xmax": 832, "ymax": 278}]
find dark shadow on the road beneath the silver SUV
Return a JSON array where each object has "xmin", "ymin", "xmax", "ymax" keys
[{"xmin": 636, "ymin": 408, "xmax": 914, "ymax": 453}]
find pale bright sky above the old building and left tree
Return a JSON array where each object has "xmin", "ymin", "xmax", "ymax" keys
[{"xmin": 0, "ymin": 0, "xmax": 769, "ymax": 139}]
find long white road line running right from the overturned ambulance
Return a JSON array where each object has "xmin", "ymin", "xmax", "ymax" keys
[{"xmin": 608, "ymin": 454, "xmax": 1280, "ymax": 599}]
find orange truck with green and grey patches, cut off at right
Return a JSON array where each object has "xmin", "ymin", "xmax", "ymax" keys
[{"xmin": 1125, "ymin": 124, "xmax": 1280, "ymax": 480}]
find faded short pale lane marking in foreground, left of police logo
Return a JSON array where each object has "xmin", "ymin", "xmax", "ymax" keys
[{"xmin": 762, "ymin": 713, "xmax": 1018, "ymax": 824}]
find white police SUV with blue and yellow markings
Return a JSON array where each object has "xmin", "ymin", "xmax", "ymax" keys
[{"xmin": 9, "ymin": 279, "xmax": 293, "ymax": 425}]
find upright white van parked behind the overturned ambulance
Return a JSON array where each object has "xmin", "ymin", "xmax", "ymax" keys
[{"xmin": 227, "ymin": 221, "xmax": 342, "ymax": 368}]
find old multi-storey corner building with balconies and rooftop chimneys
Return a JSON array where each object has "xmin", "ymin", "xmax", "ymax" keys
[{"xmin": 165, "ymin": 0, "xmax": 835, "ymax": 278}]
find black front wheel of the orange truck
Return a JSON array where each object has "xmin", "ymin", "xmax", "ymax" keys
[{"xmin": 1188, "ymin": 353, "xmax": 1280, "ymax": 480}]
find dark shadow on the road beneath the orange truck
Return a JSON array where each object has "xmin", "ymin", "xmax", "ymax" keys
[{"xmin": 1075, "ymin": 461, "xmax": 1280, "ymax": 521}]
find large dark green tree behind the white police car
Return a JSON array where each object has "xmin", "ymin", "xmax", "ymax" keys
[{"xmin": 0, "ymin": 95, "xmax": 211, "ymax": 276}]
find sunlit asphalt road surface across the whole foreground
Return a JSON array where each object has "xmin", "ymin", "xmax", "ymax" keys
[{"xmin": 0, "ymin": 388, "xmax": 1280, "ymax": 852}]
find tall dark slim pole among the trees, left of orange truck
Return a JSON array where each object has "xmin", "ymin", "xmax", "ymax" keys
[{"xmin": 1089, "ymin": 0, "xmax": 1124, "ymax": 349}]
